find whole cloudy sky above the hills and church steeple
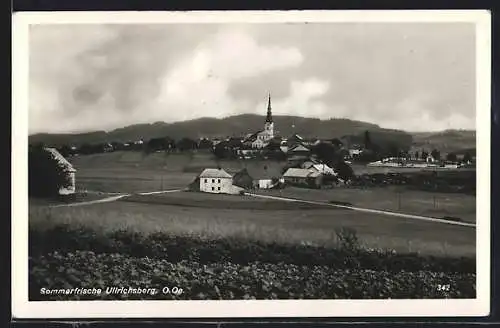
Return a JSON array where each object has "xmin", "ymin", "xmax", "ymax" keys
[{"xmin": 28, "ymin": 23, "xmax": 476, "ymax": 133}]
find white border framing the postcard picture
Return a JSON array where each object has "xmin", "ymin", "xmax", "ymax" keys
[{"xmin": 11, "ymin": 10, "xmax": 491, "ymax": 319}]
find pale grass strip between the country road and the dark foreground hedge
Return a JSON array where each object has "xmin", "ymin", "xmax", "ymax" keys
[{"xmin": 30, "ymin": 194, "xmax": 475, "ymax": 256}]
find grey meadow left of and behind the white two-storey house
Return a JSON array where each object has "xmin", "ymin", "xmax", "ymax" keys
[{"xmin": 70, "ymin": 152, "xmax": 284, "ymax": 193}]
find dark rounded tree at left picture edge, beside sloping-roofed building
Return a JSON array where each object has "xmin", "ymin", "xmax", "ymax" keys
[{"xmin": 28, "ymin": 146, "xmax": 71, "ymax": 197}]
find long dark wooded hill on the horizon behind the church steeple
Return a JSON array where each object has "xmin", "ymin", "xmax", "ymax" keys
[{"xmin": 29, "ymin": 114, "xmax": 411, "ymax": 146}]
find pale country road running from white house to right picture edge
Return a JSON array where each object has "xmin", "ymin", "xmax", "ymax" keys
[{"xmin": 245, "ymin": 193, "xmax": 476, "ymax": 228}]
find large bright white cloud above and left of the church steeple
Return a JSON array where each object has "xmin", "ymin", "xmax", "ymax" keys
[{"xmin": 143, "ymin": 31, "xmax": 303, "ymax": 121}]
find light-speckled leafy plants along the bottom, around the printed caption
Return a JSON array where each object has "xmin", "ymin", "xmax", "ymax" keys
[{"xmin": 29, "ymin": 251, "xmax": 476, "ymax": 300}]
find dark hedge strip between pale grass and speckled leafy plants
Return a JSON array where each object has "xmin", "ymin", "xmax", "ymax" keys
[{"xmin": 29, "ymin": 225, "xmax": 476, "ymax": 273}]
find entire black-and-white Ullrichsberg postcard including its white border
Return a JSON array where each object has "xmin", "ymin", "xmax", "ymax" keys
[{"xmin": 12, "ymin": 11, "xmax": 491, "ymax": 318}]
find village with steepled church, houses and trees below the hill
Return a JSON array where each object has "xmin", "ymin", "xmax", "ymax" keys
[{"xmin": 33, "ymin": 94, "xmax": 475, "ymax": 199}]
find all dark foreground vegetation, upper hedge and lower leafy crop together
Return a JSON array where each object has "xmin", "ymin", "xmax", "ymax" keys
[{"xmin": 29, "ymin": 225, "xmax": 476, "ymax": 300}]
